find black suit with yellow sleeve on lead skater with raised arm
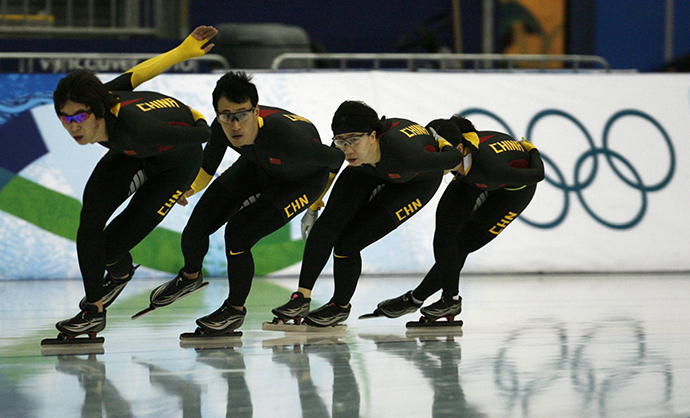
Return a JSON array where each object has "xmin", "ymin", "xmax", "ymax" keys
[{"xmin": 77, "ymin": 36, "xmax": 210, "ymax": 303}]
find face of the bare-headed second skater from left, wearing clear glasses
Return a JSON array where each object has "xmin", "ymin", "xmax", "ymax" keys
[{"xmin": 217, "ymin": 96, "xmax": 259, "ymax": 147}]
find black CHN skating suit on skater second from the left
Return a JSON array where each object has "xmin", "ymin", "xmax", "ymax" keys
[{"xmin": 182, "ymin": 106, "xmax": 344, "ymax": 306}]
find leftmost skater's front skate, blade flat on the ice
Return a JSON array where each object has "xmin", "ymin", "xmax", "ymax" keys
[{"xmin": 41, "ymin": 304, "xmax": 105, "ymax": 354}]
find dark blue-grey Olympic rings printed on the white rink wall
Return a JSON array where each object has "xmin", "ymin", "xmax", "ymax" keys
[{"xmin": 457, "ymin": 108, "xmax": 676, "ymax": 229}]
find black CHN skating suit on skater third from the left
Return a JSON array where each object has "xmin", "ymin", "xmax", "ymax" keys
[{"xmin": 299, "ymin": 119, "xmax": 462, "ymax": 306}]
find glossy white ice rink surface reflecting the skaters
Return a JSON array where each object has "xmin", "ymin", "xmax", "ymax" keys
[{"xmin": 0, "ymin": 274, "xmax": 690, "ymax": 418}]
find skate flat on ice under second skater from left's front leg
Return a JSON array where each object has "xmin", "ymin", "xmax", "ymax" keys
[{"xmin": 180, "ymin": 301, "xmax": 247, "ymax": 345}]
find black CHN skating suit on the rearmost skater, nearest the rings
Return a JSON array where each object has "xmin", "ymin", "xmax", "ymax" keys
[{"xmin": 413, "ymin": 131, "xmax": 544, "ymax": 300}]
